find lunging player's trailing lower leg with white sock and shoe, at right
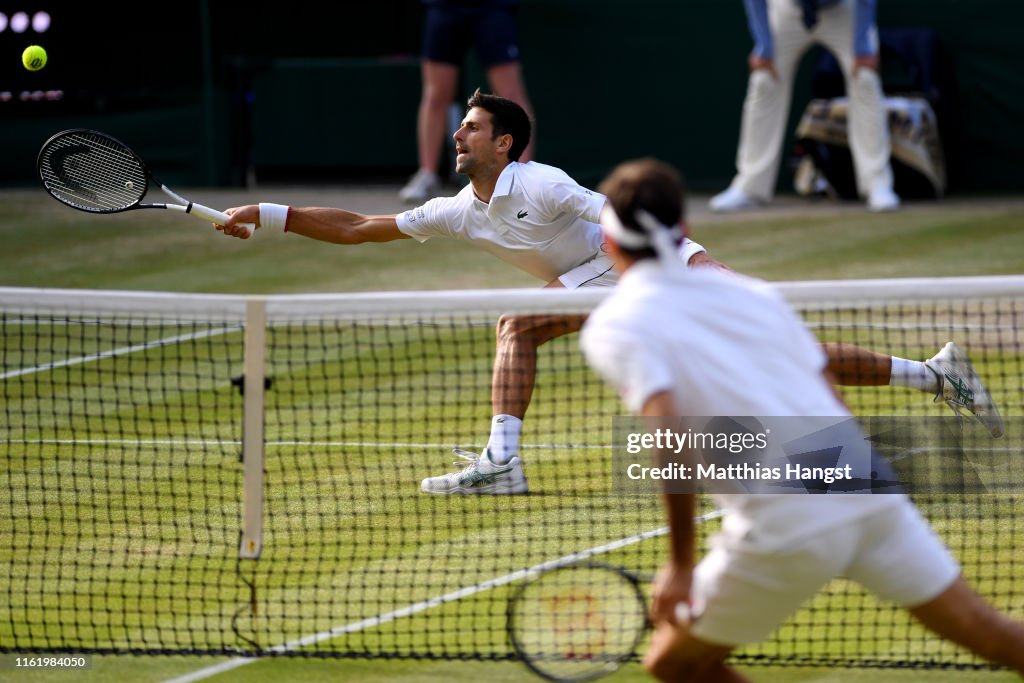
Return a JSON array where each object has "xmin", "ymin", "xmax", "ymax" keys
[{"xmin": 821, "ymin": 342, "xmax": 1002, "ymax": 438}]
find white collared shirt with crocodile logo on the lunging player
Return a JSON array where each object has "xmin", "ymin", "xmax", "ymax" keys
[{"xmin": 396, "ymin": 162, "xmax": 605, "ymax": 283}]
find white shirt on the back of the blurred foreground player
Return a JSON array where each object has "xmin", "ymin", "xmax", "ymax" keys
[{"xmin": 580, "ymin": 261, "xmax": 906, "ymax": 547}]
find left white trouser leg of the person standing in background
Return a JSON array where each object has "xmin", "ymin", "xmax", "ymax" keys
[{"xmin": 732, "ymin": 0, "xmax": 811, "ymax": 200}]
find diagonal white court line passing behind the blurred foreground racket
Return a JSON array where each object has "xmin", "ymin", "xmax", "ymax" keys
[{"xmin": 157, "ymin": 510, "xmax": 723, "ymax": 683}]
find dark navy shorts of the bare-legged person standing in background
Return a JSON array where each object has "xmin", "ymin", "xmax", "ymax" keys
[{"xmin": 423, "ymin": 2, "xmax": 519, "ymax": 68}]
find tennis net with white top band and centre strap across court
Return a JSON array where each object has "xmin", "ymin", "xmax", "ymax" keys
[{"xmin": 0, "ymin": 278, "xmax": 1024, "ymax": 668}]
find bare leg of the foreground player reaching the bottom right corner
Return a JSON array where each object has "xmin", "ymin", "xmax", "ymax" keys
[{"xmin": 909, "ymin": 579, "xmax": 1024, "ymax": 674}]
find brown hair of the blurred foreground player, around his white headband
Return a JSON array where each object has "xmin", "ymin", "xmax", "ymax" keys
[{"xmin": 597, "ymin": 158, "xmax": 686, "ymax": 260}]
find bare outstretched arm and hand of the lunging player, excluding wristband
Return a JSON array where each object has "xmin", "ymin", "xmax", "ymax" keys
[{"xmin": 216, "ymin": 204, "xmax": 409, "ymax": 245}]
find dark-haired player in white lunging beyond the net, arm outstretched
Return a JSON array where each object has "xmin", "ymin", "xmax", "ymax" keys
[{"xmin": 218, "ymin": 90, "xmax": 1002, "ymax": 494}]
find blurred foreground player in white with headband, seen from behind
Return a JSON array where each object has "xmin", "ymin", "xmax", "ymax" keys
[{"xmin": 581, "ymin": 160, "xmax": 1024, "ymax": 683}]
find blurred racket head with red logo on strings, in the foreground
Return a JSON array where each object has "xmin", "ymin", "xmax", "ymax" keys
[{"xmin": 506, "ymin": 563, "xmax": 675, "ymax": 682}]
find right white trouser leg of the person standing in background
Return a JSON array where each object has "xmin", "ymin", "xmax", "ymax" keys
[{"xmin": 819, "ymin": 0, "xmax": 893, "ymax": 196}]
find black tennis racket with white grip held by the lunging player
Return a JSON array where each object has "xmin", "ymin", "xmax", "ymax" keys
[{"xmin": 36, "ymin": 128, "xmax": 254, "ymax": 234}]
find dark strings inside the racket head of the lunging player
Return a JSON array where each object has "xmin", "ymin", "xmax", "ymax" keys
[{"xmin": 39, "ymin": 133, "xmax": 147, "ymax": 212}]
